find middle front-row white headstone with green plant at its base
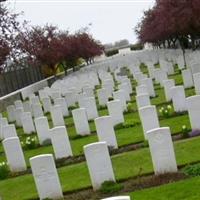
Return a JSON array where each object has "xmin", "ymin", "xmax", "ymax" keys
[{"xmin": 84, "ymin": 142, "xmax": 115, "ymax": 190}]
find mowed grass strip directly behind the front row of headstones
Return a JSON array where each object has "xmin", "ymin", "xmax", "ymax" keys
[{"xmin": 0, "ymin": 137, "xmax": 200, "ymax": 200}]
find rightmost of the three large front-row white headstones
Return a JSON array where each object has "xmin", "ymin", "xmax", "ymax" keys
[{"xmin": 147, "ymin": 128, "xmax": 177, "ymax": 174}]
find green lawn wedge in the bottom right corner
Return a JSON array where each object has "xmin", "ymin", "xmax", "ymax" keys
[{"xmin": 130, "ymin": 177, "xmax": 200, "ymax": 200}]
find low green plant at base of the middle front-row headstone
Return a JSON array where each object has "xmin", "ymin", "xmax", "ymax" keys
[{"xmin": 100, "ymin": 181, "xmax": 123, "ymax": 194}]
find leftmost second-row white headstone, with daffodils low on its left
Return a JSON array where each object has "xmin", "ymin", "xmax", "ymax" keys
[{"xmin": 2, "ymin": 137, "xmax": 26, "ymax": 172}]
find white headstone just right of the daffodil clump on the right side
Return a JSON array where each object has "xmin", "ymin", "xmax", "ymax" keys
[{"xmin": 171, "ymin": 86, "xmax": 187, "ymax": 112}]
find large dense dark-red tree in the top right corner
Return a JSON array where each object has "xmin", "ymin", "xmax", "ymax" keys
[{"xmin": 136, "ymin": 0, "xmax": 200, "ymax": 48}]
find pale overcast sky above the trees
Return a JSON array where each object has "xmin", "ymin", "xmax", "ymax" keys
[{"xmin": 5, "ymin": 0, "xmax": 154, "ymax": 44}]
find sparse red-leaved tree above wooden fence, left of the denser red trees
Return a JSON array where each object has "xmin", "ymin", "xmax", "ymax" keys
[{"xmin": 18, "ymin": 25, "xmax": 63, "ymax": 73}]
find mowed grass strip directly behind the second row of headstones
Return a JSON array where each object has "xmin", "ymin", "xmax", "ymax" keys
[{"xmin": 0, "ymin": 115, "xmax": 190, "ymax": 166}]
